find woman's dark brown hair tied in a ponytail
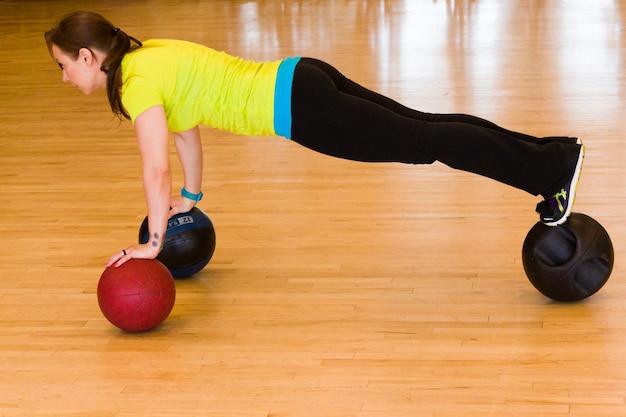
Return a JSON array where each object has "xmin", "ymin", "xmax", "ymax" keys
[{"xmin": 45, "ymin": 12, "xmax": 141, "ymax": 119}]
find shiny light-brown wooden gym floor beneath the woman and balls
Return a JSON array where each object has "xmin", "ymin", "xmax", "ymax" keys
[{"xmin": 0, "ymin": 0, "xmax": 626, "ymax": 417}]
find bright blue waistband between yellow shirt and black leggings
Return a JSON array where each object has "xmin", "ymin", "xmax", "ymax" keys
[{"xmin": 274, "ymin": 56, "xmax": 300, "ymax": 139}]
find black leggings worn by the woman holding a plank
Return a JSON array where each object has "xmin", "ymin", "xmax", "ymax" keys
[{"xmin": 291, "ymin": 58, "xmax": 579, "ymax": 197}]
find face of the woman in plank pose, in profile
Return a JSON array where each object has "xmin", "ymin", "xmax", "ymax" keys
[{"xmin": 52, "ymin": 45, "xmax": 107, "ymax": 95}]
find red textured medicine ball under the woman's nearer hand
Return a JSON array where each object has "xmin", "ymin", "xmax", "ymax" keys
[{"xmin": 97, "ymin": 259, "xmax": 176, "ymax": 332}]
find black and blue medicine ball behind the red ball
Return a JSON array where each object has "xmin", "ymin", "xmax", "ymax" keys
[{"xmin": 139, "ymin": 207, "xmax": 215, "ymax": 278}]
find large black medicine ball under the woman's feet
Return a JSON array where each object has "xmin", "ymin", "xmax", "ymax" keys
[{"xmin": 522, "ymin": 213, "xmax": 614, "ymax": 301}]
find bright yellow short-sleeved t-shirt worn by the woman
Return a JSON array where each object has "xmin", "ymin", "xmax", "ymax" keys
[{"xmin": 121, "ymin": 39, "xmax": 281, "ymax": 136}]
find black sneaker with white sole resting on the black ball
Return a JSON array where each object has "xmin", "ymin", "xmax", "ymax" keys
[{"xmin": 537, "ymin": 145, "xmax": 585, "ymax": 226}]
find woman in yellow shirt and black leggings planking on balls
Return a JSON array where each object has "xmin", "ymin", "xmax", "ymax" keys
[{"xmin": 45, "ymin": 12, "xmax": 584, "ymax": 266}]
